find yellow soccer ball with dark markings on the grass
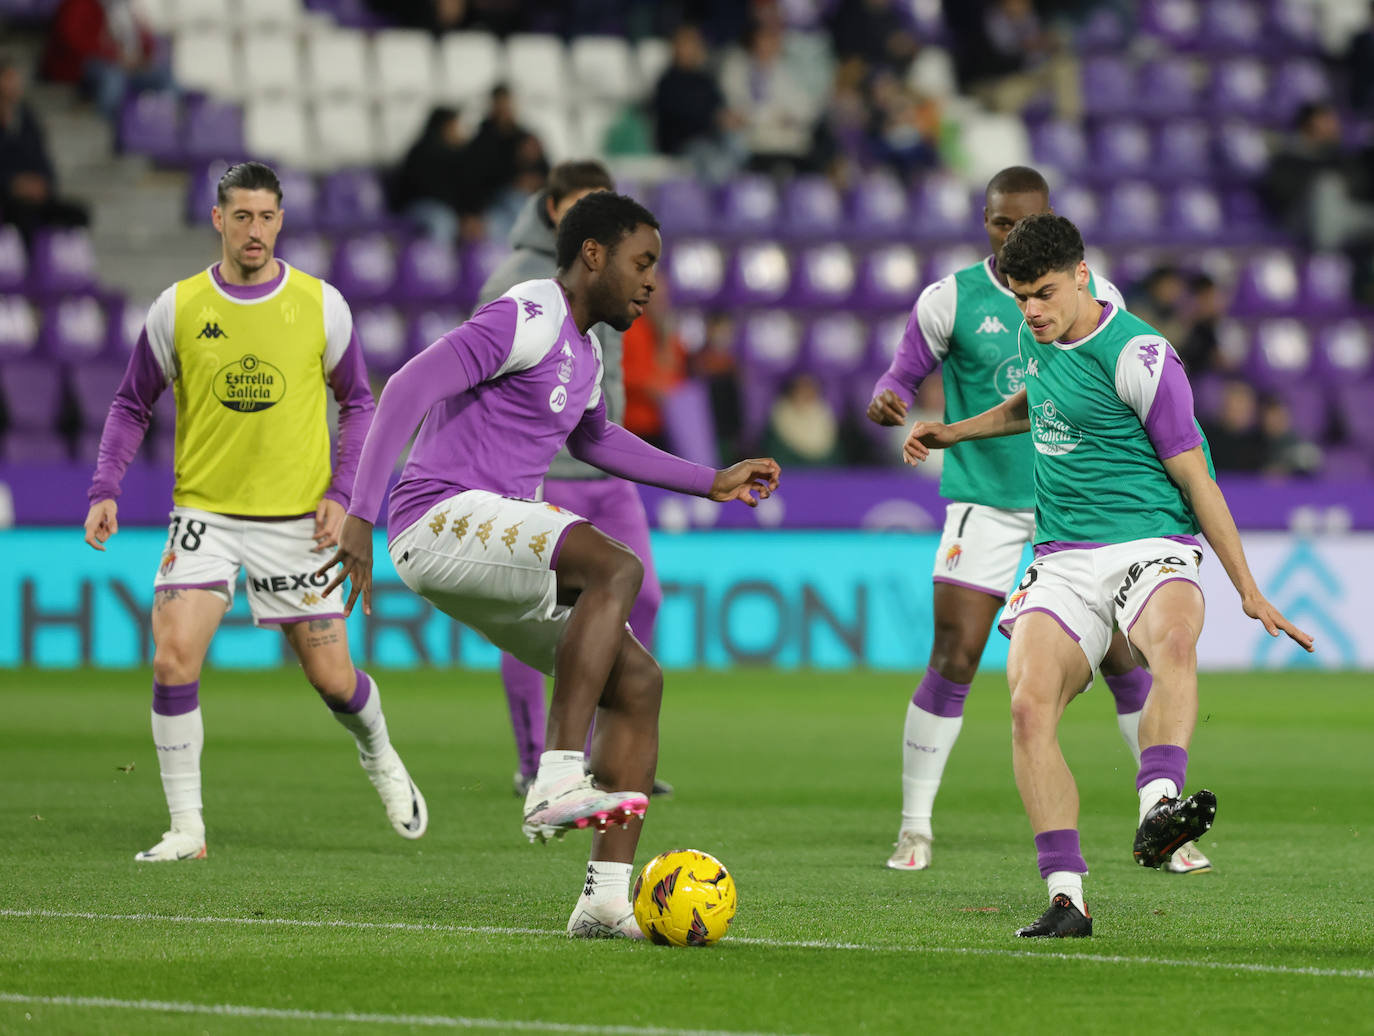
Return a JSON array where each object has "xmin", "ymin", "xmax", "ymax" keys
[{"xmin": 633, "ymin": 849, "xmax": 735, "ymax": 947}]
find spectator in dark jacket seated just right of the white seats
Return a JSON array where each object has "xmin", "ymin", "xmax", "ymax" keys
[{"xmin": 653, "ymin": 25, "xmax": 742, "ymax": 183}]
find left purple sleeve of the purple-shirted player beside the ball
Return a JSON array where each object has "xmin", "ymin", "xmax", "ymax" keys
[{"xmin": 348, "ymin": 300, "xmax": 515, "ymax": 523}]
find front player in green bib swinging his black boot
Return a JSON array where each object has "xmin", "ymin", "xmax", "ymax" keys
[{"xmin": 904, "ymin": 213, "xmax": 1312, "ymax": 937}]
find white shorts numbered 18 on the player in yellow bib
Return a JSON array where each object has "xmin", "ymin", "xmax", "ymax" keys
[{"xmin": 153, "ymin": 507, "xmax": 344, "ymax": 627}]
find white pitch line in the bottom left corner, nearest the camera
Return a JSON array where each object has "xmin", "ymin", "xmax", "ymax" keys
[{"xmin": 0, "ymin": 992, "xmax": 802, "ymax": 1036}]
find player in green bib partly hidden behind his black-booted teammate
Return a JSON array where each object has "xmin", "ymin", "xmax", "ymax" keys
[{"xmin": 868, "ymin": 166, "xmax": 1210, "ymax": 872}]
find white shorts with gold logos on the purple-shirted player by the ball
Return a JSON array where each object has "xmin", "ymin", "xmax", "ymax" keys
[{"xmin": 389, "ymin": 489, "xmax": 587, "ymax": 675}]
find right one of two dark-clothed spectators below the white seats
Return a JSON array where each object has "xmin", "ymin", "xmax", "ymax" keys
[{"xmin": 467, "ymin": 84, "xmax": 548, "ymax": 240}]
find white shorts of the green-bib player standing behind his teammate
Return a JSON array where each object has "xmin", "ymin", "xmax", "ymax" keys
[{"xmin": 930, "ymin": 503, "xmax": 1035, "ymax": 599}]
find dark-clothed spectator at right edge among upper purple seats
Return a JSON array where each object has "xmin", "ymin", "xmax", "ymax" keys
[{"xmin": 1263, "ymin": 102, "xmax": 1374, "ymax": 249}]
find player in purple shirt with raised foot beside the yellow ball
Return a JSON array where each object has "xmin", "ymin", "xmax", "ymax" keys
[{"xmin": 320, "ymin": 191, "xmax": 779, "ymax": 938}]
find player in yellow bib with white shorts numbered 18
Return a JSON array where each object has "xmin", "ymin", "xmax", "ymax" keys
[{"xmin": 85, "ymin": 162, "xmax": 429, "ymax": 862}]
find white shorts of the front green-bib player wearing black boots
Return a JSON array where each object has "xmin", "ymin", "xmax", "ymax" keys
[{"xmin": 998, "ymin": 539, "xmax": 1202, "ymax": 669}]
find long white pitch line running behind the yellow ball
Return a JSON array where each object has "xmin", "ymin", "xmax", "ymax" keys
[{"xmin": 0, "ymin": 908, "xmax": 1374, "ymax": 978}]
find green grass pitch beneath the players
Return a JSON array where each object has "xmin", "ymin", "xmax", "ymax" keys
[{"xmin": 0, "ymin": 671, "xmax": 1374, "ymax": 1036}]
